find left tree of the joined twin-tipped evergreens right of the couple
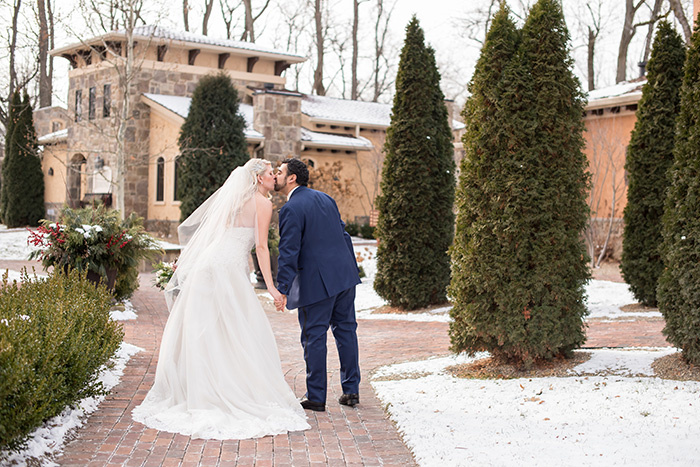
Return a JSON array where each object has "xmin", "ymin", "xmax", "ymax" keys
[{"xmin": 449, "ymin": 3, "xmax": 527, "ymax": 358}]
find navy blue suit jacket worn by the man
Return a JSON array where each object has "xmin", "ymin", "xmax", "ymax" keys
[{"xmin": 277, "ymin": 186, "xmax": 360, "ymax": 308}]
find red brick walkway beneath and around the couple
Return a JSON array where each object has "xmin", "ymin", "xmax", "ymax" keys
[{"xmin": 0, "ymin": 261, "xmax": 668, "ymax": 467}]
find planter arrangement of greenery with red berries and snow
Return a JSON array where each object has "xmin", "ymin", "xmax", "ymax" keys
[{"xmin": 29, "ymin": 206, "xmax": 159, "ymax": 300}]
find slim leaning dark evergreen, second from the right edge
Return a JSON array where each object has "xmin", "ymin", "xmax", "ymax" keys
[{"xmin": 620, "ymin": 21, "xmax": 685, "ymax": 306}]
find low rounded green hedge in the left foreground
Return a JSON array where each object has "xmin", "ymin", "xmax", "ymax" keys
[{"xmin": 0, "ymin": 271, "xmax": 124, "ymax": 449}]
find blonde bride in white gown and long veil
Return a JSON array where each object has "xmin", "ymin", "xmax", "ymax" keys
[{"xmin": 132, "ymin": 159, "xmax": 310, "ymax": 439}]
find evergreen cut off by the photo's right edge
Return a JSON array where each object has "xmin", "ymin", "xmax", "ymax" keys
[{"xmin": 657, "ymin": 16, "xmax": 700, "ymax": 365}]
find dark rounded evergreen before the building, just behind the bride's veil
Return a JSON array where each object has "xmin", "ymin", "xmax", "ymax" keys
[{"xmin": 178, "ymin": 73, "xmax": 250, "ymax": 220}]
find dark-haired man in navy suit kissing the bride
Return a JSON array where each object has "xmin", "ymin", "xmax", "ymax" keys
[{"xmin": 275, "ymin": 159, "xmax": 360, "ymax": 412}]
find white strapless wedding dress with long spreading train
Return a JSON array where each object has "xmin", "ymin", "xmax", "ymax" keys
[{"xmin": 133, "ymin": 227, "xmax": 310, "ymax": 439}]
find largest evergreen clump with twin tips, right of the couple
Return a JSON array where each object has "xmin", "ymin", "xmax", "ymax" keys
[{"xmin": 450, "ymin": 0, "xmax": 589, "ymax": 364}]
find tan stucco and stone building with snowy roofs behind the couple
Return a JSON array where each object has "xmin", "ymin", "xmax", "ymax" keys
[{"xmin": 35, "ymin": 26, "xmax": 463, "ymax": 234}]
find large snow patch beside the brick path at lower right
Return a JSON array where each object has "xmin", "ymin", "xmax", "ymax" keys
[{"xmin": 372, "ymin": 349, "xmax": 700, "ymax": 467}]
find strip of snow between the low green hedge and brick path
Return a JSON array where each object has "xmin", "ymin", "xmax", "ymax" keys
[{"xmin": 0, "ymin": 343, "xmax": 143, "ymax": 467}]
